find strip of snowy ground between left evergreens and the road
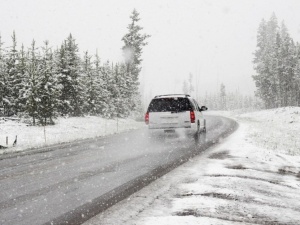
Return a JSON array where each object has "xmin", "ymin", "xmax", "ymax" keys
[{"xmin": 0, "ymin": 116, "xmax": 145, "ymax": 154}]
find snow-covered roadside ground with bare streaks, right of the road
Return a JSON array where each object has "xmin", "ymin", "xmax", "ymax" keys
[{"xmin": 85, "ymin": 107, "xmax": 300, "ymax": 225}]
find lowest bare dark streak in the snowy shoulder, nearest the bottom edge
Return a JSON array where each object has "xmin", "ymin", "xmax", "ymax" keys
[{"xmin": 173, "ymin": 209, "xmax": 294, "ymax": 225}]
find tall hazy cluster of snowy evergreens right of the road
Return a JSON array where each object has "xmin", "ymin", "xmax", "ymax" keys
[{"xmin": 253, "ymin": 14, "xmax": 300, "ymax": 108}]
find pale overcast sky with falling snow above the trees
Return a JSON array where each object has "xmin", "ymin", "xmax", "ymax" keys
[{"xmin": 0, "ymin": 0, "xmax": 300, "ymax": 100}]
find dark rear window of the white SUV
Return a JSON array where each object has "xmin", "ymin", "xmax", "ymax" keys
[{"xmin": 148, "ymin": 98, "xmax": 192, "ymax": 112}]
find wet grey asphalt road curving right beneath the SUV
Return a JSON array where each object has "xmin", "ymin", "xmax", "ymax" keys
[{"xmin": 0, "ymin": 116, "xmax": 237, "ymax": 225}]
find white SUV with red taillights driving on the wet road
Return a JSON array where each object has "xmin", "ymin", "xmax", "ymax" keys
[{"xmin": 145, "ymin": 94, "xmax": 207, "ymax": 133}]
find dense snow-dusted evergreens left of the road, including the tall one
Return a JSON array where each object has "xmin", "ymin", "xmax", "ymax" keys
[{"xmin": 0, "ymin": 10, "xmax": 149, "ymax": 125}]
